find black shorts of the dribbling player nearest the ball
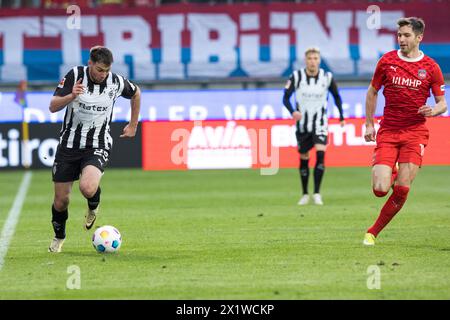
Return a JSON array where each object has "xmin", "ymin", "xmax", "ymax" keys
[{"xmin": 52, "ymin": 145, "xmax": 109, "ymax": 182}]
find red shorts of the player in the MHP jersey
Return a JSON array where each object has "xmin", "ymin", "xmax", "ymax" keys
[{"xmin": 373, "ymin": 124, "xmax": 429, "ymax": 167}]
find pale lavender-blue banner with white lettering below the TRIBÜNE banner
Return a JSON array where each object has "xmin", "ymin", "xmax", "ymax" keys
[{"xmin": 0, "ymin": 86, "xmax": 450, "ymax": 123}]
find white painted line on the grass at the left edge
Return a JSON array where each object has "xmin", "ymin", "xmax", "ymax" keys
[{"xmin": 0, "ymin": 171, "xmax": 31, "ymax": 271}]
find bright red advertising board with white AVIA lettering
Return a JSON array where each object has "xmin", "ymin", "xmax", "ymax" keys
[{"xmin": 142, "ymin": 117, "xmax": 450, "ymax": 173}]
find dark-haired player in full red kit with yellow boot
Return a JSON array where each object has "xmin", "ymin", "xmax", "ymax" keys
[{"xmin": 363, "ymin": 17, "xmax": 447, "ymax": 245}]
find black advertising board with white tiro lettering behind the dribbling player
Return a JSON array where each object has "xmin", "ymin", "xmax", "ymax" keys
[{"xmin": 0, "ymin": 123, "xmax": 142, "ymax": 170}]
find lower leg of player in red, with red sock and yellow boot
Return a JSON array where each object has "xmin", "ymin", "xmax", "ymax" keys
[{"xmin": 364, "ymin": 163, "xmax": 419, "ymax": 245}]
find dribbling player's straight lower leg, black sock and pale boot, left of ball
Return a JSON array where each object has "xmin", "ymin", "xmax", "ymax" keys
[{"xmin": 48, "ymin": 182, "xmax": 73, "ymax": 252}]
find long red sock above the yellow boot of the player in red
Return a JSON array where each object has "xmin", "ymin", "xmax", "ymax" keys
[{"xmin": 367, "ymin": 186, "xmax": 409, "ymax": 237}]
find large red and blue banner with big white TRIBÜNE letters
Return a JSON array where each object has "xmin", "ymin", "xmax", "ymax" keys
[{"xmin": 0, "ymin": 1, "xmax": 450, "ymax": 82}]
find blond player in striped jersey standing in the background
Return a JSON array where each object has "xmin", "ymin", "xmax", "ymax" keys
[{"xmin": 283, "ymin": 48, "xmax": 345, "ymax": 205}]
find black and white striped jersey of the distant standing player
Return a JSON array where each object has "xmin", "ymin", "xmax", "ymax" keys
[{"xmin": 283, "ymin": 69, "xmax": 344, "ymax": 135}]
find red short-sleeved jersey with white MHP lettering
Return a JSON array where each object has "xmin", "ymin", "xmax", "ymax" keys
[{"xmin": 371, "ymin": 50, "xmax": 445, "ymax": 129}]
